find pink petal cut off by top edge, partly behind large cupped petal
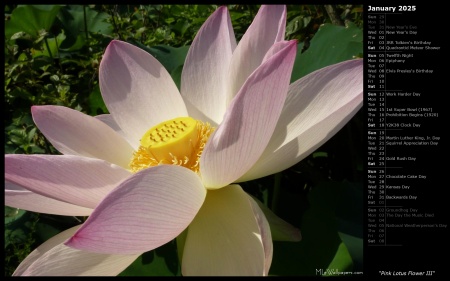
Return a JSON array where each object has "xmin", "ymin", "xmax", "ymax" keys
[{"xmin": 228, "ymin": 5, "xmax": 286, "ymax": 101}]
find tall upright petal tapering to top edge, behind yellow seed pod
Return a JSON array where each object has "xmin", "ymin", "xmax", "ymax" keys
[{"xmin": 181, "ymin": 6, "xmax": 236, "ymax": 125}]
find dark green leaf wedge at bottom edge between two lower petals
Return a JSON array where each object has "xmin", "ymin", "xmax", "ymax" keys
[{"xmin": 119, "ymin": 238, "xmax": 181, "ymax": 276}]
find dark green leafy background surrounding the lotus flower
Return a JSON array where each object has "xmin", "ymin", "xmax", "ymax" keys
[{"xmin": 4, "ymin": 5, "xmax": 363, "ymax": 276}]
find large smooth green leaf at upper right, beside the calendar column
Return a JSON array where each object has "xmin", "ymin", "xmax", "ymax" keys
[{"xmin": 291, "ymin": 24, "xmax": 363, "ymax": 83}]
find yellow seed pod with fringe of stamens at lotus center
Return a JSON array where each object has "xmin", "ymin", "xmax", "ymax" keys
[{"xmin": 130, "ymin": 117, "xmax": 215, "ymax": 173}]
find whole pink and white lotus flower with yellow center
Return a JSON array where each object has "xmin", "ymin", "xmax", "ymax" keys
[{"xmin": 5, "ymin": 5, "xmax": 363, "ymax": 275}]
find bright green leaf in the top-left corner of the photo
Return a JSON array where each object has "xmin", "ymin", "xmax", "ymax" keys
[{"xmin": 5, "ymin": 5, "xmax": 61, "ymax": 39}]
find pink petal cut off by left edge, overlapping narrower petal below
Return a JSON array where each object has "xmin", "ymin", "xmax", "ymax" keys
[{"xmin": 5, "ymin": 154, "xmax": 131, "ymax": 209}]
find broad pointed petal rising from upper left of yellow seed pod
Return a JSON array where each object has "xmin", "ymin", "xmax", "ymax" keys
[{"xmin": 99, "ymin": 40, "xmax": 187, "ymax": 147}]
